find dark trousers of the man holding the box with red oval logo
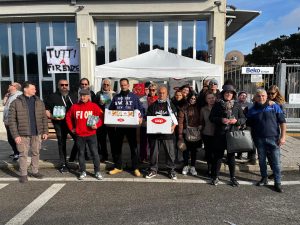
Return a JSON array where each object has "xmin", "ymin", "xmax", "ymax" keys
[{"xmin": 149, "ymin": 138, "xmax": 175, "ymax": 172}]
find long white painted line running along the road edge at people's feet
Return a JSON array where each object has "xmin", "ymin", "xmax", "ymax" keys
[{"xmin": 0, "ymin": 177, "xmax": 300, "ymax": 185}]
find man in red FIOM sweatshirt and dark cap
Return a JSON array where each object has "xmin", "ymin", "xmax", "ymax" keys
[{"xmin": 66, "ymin": 89, "xmax": 103, "ymax": 180}]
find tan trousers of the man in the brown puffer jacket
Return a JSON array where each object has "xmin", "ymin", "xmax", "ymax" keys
[{"xmin": 17, "ymin": 135, "xmax": 42, "ymax": 176}]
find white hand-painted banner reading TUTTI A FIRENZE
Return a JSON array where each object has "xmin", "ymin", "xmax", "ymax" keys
[{"xmin": 46, "ymin": 46, "xmax": 80, "ymax": 73}]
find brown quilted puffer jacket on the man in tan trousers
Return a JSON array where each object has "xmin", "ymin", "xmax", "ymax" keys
[{"xmin": 8, "ymin": 95, "xmax": 48, "ymax": 139}]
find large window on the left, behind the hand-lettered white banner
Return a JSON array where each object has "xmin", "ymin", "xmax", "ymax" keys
[{"xmin": 0, "ymin": 21, "xmax": 79, "ymax": 99}]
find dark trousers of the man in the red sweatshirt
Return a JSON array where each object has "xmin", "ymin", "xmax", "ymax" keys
[{"xmin": 76, "ymin": 135, "xmax": 100, "ymax": 173}]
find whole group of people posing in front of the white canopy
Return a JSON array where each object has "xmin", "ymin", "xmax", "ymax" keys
[{"xmin": 3, "ymin": 78, "xmax": 286, "ymax": 192}]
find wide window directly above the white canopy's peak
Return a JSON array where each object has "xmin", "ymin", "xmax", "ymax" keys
[{"xmin": 137, "ymin": 20, "xmax": 208, "ymax": 61}]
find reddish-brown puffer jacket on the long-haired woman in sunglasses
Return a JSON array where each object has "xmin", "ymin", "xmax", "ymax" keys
[{"xmin": 178, "ymin": 104, "xmax": 201, "ymax": 135}]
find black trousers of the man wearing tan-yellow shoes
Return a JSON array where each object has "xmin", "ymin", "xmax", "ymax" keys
[{"xmin": 113, "ymin": 127, "xmax": 138, "ymax": 170}]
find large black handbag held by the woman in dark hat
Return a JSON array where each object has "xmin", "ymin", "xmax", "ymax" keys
[{"xmin": 226, "ymin": 130, "xmax": 254, "ymax": 153}]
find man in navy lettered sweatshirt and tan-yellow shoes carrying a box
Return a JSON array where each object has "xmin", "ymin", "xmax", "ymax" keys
[{"xmin": 109, "ymin": 78, "xmax": 144, "ymax": 177}]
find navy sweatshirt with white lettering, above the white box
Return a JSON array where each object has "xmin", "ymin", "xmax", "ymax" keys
[{"xmin": 109, "ymin": 92, "xmax": 145, "ymax": 117}]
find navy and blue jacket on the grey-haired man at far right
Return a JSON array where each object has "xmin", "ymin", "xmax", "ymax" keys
[{"xmin": 246, "ymin": 103, "xmax": 286, "ymax": 138}]
